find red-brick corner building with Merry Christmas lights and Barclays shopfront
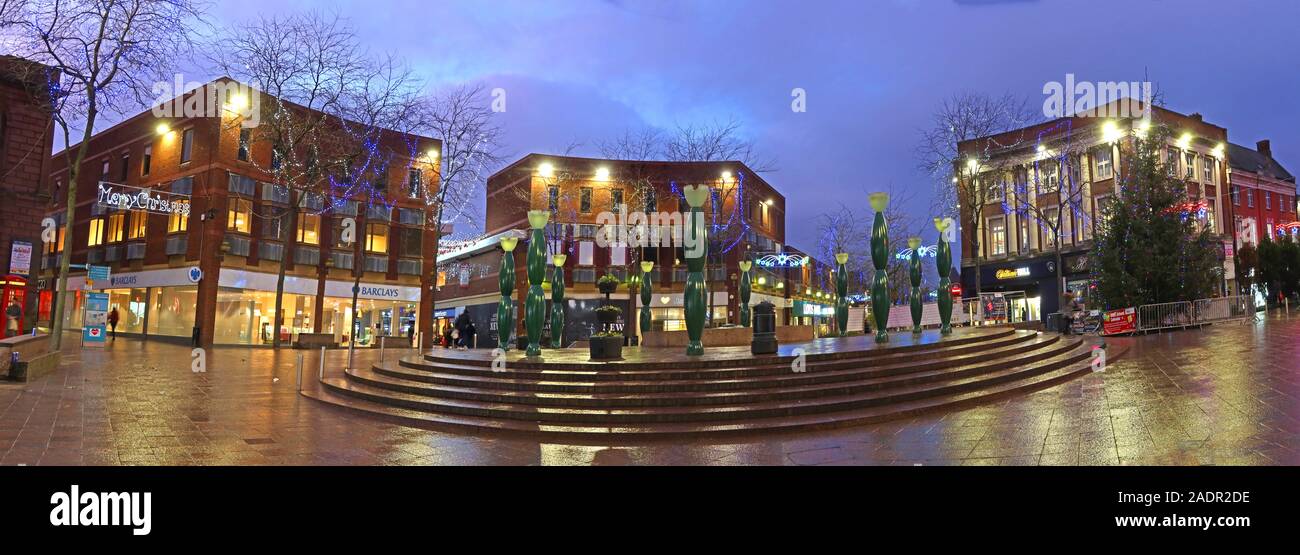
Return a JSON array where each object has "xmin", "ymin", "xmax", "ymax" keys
[{"xmin": 40, "ymin": 79, "xmax": 441, "ymax": 346}]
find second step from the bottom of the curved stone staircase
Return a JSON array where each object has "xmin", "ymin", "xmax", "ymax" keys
[{"xmin": 322, "ymin": 343, "xmax": 1088, "ymax": 425}]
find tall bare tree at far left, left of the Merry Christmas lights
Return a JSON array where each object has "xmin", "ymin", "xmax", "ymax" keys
[{"xmin": 0, "ymin": 0, "xmax": 207, "ymax": 348}]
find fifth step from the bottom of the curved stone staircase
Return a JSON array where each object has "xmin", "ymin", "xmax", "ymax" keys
[{"xmin": 398, "ymin": 330, "xmax": 1037, "ymax": 382}]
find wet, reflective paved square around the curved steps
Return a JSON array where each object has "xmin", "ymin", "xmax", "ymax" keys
[{"xmin": 0, "ymin": 313, "xmax": 1300, "ymax": 465}]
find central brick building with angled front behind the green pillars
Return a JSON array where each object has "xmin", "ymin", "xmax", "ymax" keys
[{"xmin": 426, "ymin": 153, "xmax": 826, "ymax": 346}]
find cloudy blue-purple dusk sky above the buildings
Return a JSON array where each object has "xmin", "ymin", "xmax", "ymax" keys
[{"xmin": 208, "ymin": 0, "xmax": 1300, "ymax": 250}]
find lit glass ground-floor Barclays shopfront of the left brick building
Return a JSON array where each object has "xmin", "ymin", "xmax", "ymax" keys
[{"xmin": 42, "ymin": 268, "xmax": 420, "ymax": 346}]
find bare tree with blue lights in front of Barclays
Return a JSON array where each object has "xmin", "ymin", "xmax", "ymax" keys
[{"xmin": 213, "ymin": 13, "xmax": 425, "ymax": 346}]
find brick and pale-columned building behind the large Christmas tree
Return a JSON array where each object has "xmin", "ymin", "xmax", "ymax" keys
[{"xmin": 957, "ymin": 107, "xmax": 1232, "ymax": 320}]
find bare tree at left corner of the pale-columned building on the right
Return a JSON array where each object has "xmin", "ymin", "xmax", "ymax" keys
[{"xmin": 915, "ymin": 91, "xmax": 1039, "ymax": 300}]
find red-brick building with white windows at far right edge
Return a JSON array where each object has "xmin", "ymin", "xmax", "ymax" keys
[{"xmin": 1227, "ymin": 140, "xmax": 1300, "ymax": 290}]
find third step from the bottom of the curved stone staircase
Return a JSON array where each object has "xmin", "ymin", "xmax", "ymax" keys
[{"xmin": 358, "ymin": 338, "xmax": 1076, "ymax": 408}]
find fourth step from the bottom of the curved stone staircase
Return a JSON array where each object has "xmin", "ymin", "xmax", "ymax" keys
[{"xmin": 367, "ymin": 334, "xmax": 1061, "ymax": 398}]
